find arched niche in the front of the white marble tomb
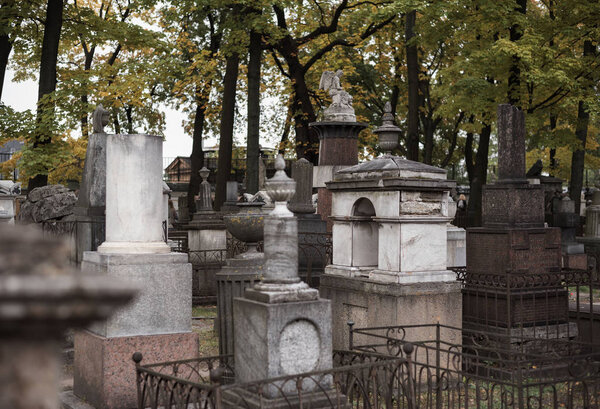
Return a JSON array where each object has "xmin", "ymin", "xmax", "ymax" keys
[{"xmin": 352, "ymin": 197, "xmax": 379, "ymax": 267}]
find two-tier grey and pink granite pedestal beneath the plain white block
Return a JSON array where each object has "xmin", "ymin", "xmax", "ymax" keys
[{"xmin": 73, "ymin": 252, "xmax": 198, "ymax": 408}]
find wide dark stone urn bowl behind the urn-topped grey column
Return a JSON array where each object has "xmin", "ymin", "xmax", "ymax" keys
[{"xmin": 223, "ymin": 202, "xmax": 265, "ymax": 258}]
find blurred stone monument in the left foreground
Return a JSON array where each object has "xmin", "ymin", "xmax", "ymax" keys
[{"xmin": 0, "ymin": 225, "xmax": 136, "ymax": 409}]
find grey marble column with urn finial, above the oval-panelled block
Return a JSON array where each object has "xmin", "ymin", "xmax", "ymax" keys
[{"xmin": 246, "ymin": 154, "xmax": 319, "ymax": 303}]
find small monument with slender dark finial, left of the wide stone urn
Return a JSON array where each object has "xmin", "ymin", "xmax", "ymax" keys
[{"xmin": 188, "ymin": 167, "xmax": 227, "ymax": 302}]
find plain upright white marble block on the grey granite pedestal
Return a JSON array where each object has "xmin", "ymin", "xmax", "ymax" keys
[{"xmin": 98, "ymin": 134, "xmax": 170, "ymax": 254}]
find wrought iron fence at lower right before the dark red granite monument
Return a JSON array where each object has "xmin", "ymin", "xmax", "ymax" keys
[{"xmin": 349, "ymin": 323, "xmax": 600, "ymax": 409}]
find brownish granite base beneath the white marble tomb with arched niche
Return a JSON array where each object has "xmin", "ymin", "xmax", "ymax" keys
[{"xmin": 319, "ymin": 274, "xmax": 462, "ymax": 349}]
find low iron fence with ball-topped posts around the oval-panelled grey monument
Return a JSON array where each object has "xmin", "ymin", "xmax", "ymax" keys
[{"xmin": 134, "ymin": 351, "xmax": 416, "ymax": 409}]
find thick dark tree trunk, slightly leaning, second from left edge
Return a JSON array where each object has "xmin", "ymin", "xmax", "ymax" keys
[{"xmin": 28, "ymin": 0, "xmax": 63, "ymax": 191}]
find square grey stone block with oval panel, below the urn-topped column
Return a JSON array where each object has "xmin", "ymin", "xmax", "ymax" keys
[{"xmin": 234, "ymin": 298, "xmax": 332, "ymax": 397}]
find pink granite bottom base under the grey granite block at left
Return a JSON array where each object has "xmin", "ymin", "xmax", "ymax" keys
[{"xmin": 73, "ymin": 331, "xmax": 199, "ymax": 409}]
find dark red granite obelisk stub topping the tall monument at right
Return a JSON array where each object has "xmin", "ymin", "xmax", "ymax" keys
[{"xmin": 498, "ymin": 104, "xmax": 527, "ymax": 183}]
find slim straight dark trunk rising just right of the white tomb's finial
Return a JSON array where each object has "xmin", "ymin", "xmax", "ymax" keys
[{"xmin": 405, "ymin": 10, "xmax": 419, "ymax": 161}]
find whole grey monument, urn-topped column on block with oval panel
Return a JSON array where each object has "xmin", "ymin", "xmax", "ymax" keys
[{"xmin": 233, "ymin": 155, "xmax": 332, "ymax": 396}]
